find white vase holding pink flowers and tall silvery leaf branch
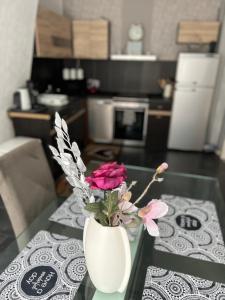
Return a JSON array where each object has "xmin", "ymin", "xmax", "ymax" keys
[{"xmin": 50, "ymin": 113, "xmax": 168, "ymax": 293}]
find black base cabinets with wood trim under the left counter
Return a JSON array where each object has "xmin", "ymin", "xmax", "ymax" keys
[{"xmin": 8, "ymin": 99, "xmax": 87, "ymax": 178}]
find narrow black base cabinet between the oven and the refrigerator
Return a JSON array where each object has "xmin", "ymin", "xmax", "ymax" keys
[{"xmin": 146, "ymin": 100, "xmax": 171, "ymax": 151}]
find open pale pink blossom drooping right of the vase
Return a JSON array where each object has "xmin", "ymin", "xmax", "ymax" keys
[{"xmin": 138, "ymin": 199, "xmax": 168, "ymax": 236}]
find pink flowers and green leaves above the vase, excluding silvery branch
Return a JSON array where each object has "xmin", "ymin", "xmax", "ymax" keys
[{"xmin": 85, "ymin": 162, "xmax": 168, "ymax": 236}]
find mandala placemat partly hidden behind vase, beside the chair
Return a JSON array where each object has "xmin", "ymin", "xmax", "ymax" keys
[{"xmin": 49, "ymin": 190, "xmax": 103, "ymax": 229}]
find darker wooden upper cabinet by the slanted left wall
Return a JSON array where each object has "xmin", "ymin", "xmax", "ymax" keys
[{"xmin": 36, "ymin": 7, "xmax": 73, "ymax": 58}]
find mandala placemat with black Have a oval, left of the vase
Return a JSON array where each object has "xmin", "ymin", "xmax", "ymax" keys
[{"xmin": 0, "ymin": 231, "xmax": 86, "ymax": 300}]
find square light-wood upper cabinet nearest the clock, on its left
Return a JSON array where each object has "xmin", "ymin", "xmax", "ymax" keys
[{"xmin": 72, "ymin": 20, "xmax": 109, "ymax": 59}]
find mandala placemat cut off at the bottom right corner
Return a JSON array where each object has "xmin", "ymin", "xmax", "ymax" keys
[{"xmin": 142, "ymin": 266, "xmax": 225, "ymax": 300}]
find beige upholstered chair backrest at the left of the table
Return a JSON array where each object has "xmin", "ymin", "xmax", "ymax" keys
[{"xmin": 0, "ymin": 137, "xmax": 56, "ymax": 236}]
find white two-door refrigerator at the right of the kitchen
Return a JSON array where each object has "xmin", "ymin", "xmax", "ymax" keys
[{"xmin": 168, "ymin": 53, "xmax": 219, "ymax": 151}]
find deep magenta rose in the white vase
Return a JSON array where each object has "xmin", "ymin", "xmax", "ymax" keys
[{"xmin": 86, "ymin": 162, "xmax": 127, "ymax": 190}]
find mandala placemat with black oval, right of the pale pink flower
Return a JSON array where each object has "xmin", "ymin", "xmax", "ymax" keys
[{"xmin": 154, "ymin": 195, "xmax": 225, "ymax": 264}]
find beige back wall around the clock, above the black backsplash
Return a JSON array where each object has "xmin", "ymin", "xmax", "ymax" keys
[{"xmin": 62, "ymin": 0, "xmax": 222, "ymax": 60}]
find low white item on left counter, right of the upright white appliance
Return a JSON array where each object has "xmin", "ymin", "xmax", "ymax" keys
[{"xmin": 38, "ymin": 94, "xmax": 69, "ymax": 107}]
